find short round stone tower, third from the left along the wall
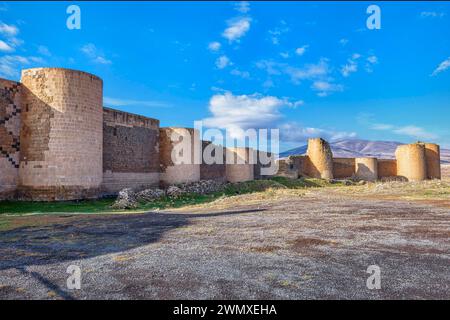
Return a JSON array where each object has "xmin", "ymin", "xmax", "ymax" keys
[{"xmin": 226, "ymin": 147, "xmax": 254, "ymax": 182}]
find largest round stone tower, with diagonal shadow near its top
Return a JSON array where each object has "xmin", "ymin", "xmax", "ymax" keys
[{"xmin": 18, "ymin": 68, "xmax": 103, "ymax": 200}]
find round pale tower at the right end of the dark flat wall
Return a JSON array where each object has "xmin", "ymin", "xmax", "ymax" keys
[{"xmin": 159, "ymin": 127, "xmax": 201, "ymax": 185}]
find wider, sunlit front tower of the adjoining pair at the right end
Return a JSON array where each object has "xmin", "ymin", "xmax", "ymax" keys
[{"xmin": 395, "ymin": 143, "xmax": 427, "ymax": 181}]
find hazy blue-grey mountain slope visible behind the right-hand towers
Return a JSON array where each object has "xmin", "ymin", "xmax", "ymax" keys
[{"xmin": 280, "ymin": 139, "xmax": 450, "ymax": 164}]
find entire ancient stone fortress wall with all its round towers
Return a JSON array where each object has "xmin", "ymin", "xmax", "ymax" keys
[{"xmin": 0, "ymin": 68, "xmax": 441, "ymax": 201}]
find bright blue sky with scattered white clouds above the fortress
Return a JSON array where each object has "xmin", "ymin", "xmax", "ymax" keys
[{"xmin": 0, "ymin": 1, "xmax": 450, "ymax": 150}]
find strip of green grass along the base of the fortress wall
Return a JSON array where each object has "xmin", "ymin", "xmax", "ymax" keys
[{"xmin": 0, "ymin": 177, "xmax": 344, "ymax": 216}]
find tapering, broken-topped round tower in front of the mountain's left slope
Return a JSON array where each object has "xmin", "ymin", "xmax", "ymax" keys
[{"xmin": 305, "ymin": 138, "xmax": 333, "ymax": 179}]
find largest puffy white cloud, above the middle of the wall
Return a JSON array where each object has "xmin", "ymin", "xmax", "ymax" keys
[{"xmin": 203, "ymin": 92, "xmax": 303, "ymax": 138}]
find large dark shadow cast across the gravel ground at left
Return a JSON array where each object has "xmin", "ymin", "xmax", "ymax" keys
[{"xmin": 0, "ymin": 209, "xmax": 264, "ymax": 270}]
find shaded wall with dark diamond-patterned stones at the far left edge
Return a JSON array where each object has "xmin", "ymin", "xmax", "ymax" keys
[{"xmin": 0, "ymin": 79, "xmax": 22, "ymax": 200}]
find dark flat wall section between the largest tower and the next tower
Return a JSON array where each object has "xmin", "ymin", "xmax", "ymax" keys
[{"xmin": 102, "ymin": 108, "xmax": 159, "ymax": 194}]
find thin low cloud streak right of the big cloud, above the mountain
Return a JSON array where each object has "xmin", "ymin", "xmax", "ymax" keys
[{"xmin": 279, "ymin": 122, "xmax": 356, "ymax": 143}]
